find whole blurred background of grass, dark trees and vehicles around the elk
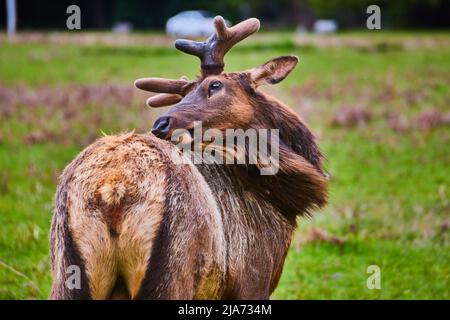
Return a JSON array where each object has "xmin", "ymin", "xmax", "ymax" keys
[{"xmin": 0, "ymin": 0, "xmax": 450, "ymax": 299}]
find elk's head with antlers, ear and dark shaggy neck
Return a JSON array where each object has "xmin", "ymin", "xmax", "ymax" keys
[{"xmin": 135, "ymin": 16, "xmax": 326, "ymax": 217}]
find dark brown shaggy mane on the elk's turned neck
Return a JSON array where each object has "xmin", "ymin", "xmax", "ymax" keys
[{"xmin": 219, "ymin": 93, "xmax": 327, "ymax": 223}]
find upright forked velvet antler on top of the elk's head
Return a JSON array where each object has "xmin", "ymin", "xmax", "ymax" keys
[{"xmin": 175, "ymin": 16, "xmax": 259, "ymax": 78}]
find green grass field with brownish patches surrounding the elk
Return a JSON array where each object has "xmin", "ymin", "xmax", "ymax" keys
[{"xmin": 0, "ymin": 32, "xmax": 450, "ymax": 299}]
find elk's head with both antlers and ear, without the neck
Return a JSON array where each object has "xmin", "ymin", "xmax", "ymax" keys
[{"xmin": 135, "ymin": 16, "xmax": 298, "ymax": 139}]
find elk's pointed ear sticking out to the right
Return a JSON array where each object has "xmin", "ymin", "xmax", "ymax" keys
[{"xmin": 250, "ymin": 56, "xmax": 298, "ymax": 87}]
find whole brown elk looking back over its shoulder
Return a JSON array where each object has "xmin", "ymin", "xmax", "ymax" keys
[{"xmin": 50, "ymin": 16, "xmax": 327, "ymax": 299}]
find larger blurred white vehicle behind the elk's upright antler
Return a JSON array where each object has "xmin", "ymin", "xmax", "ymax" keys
[{"xmin": 166, "ymin": 11, "xmax": 230, "ymax": 37}]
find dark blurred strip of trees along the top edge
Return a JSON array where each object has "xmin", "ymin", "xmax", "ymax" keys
[{"xmin": 0, "ymin": 0, "xmax": 450, "ymax": 30}]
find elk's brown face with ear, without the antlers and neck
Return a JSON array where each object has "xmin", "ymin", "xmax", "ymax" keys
[{"xmin": 136, "ymin": 56, "xmax": 297, "ymax": 139}]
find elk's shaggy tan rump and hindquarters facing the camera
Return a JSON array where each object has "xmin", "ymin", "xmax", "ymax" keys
[{"xmin": 50, "ymin": 133, "xmax": 224, "ymax": 299}]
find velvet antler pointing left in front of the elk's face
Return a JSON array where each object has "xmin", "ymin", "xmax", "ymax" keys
[{"xmin": 134, "ymin": 76, "xmax": 195, "ymax": 108}]
